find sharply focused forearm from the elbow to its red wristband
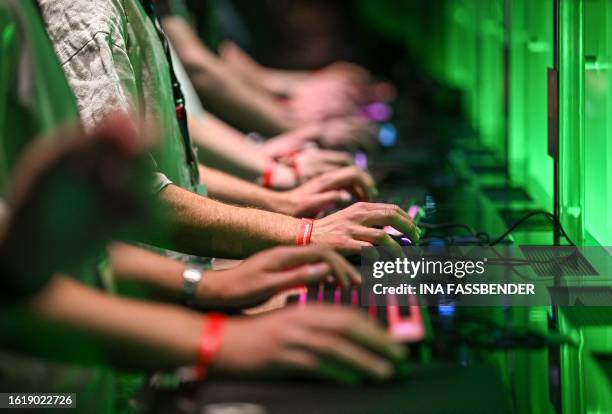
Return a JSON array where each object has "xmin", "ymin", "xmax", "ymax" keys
[{"xmin": 153, "ymin": 185, "xmax": 299, "ymax": 258}]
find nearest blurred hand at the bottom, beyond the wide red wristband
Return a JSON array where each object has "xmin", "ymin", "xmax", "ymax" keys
[{"xmin": 211, "ymin": 304, "xmax": 405, "ymax": 384}]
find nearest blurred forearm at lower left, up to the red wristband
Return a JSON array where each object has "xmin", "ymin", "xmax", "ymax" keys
[{"xmin": 0, "ymin": 276, "xmax": 204, "ymax": 369}]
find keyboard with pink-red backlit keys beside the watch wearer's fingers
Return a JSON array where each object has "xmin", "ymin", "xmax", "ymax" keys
[{"xmin": 287, "ymin": 283, "xmax": 425, "ymax": 343}]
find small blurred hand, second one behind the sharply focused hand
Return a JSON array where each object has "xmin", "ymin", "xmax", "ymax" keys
[{"xmin": 280, "ymin": 148, "xmax": 353, "ymax": 182}]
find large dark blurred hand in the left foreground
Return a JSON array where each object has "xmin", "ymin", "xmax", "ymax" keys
[{"xmin": 3, "ymin": 115, "xmax": 152, "ymax": 282}]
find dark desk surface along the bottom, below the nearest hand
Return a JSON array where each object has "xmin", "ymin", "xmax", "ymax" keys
[{"xmin": 145, "ymin": 362, "xmax": 512, "ymax": 414}]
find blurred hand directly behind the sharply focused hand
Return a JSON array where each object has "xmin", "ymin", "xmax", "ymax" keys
[{"xmin": 275, "ymin": 166, "xmax": 378, "ymax": 217}]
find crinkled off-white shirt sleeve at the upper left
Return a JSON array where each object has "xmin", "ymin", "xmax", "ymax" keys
[{"xmin": 39, "ymin": 0, "xmax": 172, "ymax": 193}]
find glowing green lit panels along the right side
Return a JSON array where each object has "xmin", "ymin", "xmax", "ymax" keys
[{"xmin": 361, "ymin": 0, "xmax": 612, "ymax": 414}]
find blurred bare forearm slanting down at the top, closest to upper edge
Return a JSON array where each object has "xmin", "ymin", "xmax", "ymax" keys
[{"xmin": 162, "ymin": 16, "xmax": 294, "ymax": 135}]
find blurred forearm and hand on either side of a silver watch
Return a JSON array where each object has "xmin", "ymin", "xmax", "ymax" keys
[{"xmin": 109, "ymin": 243, "xmax": 361, "ymax": 310}]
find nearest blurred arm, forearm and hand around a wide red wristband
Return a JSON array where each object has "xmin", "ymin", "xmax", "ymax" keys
[{"xmin": 5, "ymin": 277, "xmax": 405, "ymax": 383}]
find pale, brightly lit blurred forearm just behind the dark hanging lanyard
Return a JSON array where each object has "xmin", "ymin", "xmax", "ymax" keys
[{"xmin": 189, "ymin": 114, "xmax": 268, "ymax": 181}]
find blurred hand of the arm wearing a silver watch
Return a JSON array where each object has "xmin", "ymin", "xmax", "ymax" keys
[{"xmin": 197, "ymin": 246, "xmax": 361, "ymax": 309}]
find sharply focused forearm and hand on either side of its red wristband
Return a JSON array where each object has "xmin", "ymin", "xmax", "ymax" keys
[{"xmin": 151, "ymin": 185, "xmax": 420, "ymax": 258}]
